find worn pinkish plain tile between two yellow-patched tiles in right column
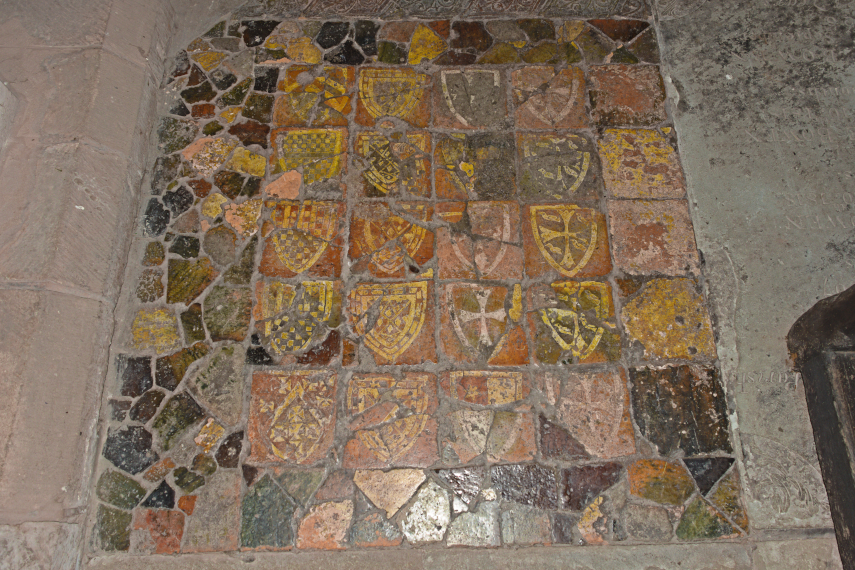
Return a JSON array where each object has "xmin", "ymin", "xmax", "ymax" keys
[{"xmin": 609, "ymin": 200, "xmax": 700, "ymax": 275}]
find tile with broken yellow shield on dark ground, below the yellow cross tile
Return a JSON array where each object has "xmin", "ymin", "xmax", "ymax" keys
[{"xmin": 527, "ymin": 281, "xmax": 621, "ymax": 364}]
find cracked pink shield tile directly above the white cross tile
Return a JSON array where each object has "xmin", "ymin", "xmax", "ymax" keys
[{"xmin": 436, "ymin": 202, "xmax": 523, "ymax": 279}]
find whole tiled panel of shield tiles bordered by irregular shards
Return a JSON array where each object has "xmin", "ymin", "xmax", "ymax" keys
[{"xmin": 91, "ymin": 13, "xmax": 748, "ymax": 553}]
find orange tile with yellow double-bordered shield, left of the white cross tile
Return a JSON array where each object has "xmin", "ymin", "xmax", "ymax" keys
[{"xmin": 347, "ymin": 281, "xmax": 436, "ymax": 364}]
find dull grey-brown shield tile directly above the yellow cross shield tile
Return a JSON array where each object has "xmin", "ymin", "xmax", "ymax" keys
[{"xmin": 517, "ymin": 131, "xmax": 603, "ymax": 202}]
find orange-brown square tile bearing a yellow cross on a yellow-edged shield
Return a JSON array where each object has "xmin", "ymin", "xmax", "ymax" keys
[{"xmin": 522, "ymin": 204, "xmax": 612, "ymax": 279}]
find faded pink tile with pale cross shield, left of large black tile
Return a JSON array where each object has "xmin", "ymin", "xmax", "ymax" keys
[{"xmin": 541, "ymin": 368, "xmax": 636, "ymax": 459}]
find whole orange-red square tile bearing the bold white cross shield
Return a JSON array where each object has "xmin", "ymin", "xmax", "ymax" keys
[{"xmin": 440, "ymin": 282, "xmax": 528, "ymax": 366}]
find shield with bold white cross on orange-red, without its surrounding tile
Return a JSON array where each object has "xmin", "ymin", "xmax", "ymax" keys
[{"xmin": 445, "ymin": 283, "xmax": 508, "ymax": 352}]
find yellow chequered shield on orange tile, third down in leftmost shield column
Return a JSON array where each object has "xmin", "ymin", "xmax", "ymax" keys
[{"xmin": 271, "ymin": 200, "xmax": 341, "ymax": 273}]
